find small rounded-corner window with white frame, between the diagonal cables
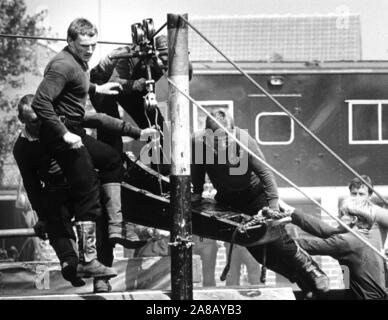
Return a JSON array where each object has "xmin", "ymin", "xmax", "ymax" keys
[{"xmin": 256, "ymin": 112, "xmax": 294, "ymax": 145}]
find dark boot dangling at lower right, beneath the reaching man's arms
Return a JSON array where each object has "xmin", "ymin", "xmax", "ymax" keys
[{"xmin": 294, "ymin": 246, "xmax": 329, "ymax": 295}]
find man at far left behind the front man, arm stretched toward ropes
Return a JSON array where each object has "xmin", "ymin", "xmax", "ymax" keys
[{"xmin": 14, "ymin": 95, "xmax": 155, "ymax": 292}]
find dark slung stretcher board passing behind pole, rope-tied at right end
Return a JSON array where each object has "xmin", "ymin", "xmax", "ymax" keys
[{"xmin": 122, "ymin": 182, "xmax": 289, "ymax": 246}]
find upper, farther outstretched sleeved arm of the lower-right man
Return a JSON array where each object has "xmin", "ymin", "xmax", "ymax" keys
[{"xmin": 291, "ymin": 209, "xmax": 346, "ymax": 238}]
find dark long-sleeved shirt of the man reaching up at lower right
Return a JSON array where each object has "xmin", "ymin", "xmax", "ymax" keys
[{"xmin": 292, "ymin": 211, "xmax": 388, "ymax": 299}]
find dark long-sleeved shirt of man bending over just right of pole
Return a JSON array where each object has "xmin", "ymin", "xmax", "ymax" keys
[{"xmin": 191, "ymin": 128, "xmax": 279, "ymax": 209}]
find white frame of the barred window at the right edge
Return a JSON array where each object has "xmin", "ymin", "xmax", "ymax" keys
[{"xmin": 345, "ymin": 100, "xmax": 388, "ymax": 144}]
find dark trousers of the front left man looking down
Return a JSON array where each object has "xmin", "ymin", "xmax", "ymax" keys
[{"xmin": 41, "ymin": 123, "xmax": 123, "ymax": 221}]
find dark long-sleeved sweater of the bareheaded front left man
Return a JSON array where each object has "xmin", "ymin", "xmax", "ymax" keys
[{"xmin": 32, "ymin": 47, "xmax": 95, "ymax": 139}]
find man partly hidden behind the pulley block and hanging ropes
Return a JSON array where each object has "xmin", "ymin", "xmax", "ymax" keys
[{"xmin": 90, "ymin": 36, "xmax": 171, "ymax": 152}]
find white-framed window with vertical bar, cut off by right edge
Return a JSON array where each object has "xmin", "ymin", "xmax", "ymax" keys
[{"xmin": 346, "ymin": 100, "xmax": 388, "ymax": 144}]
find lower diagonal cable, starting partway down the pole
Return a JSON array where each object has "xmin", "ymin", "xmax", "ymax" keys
[{"xmin": 167, "ymin": 78, "xmax": 388, "ymax": 261}]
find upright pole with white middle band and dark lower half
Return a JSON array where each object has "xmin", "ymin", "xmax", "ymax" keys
[{"xmin": 167, "ymin": 14, "xmax": 193, "ymax": 300}]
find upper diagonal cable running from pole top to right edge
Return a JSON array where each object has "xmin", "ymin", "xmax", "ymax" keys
[{"xmin": 179, "ymin": 15, "xmax": 388, "ymax": 206}]
